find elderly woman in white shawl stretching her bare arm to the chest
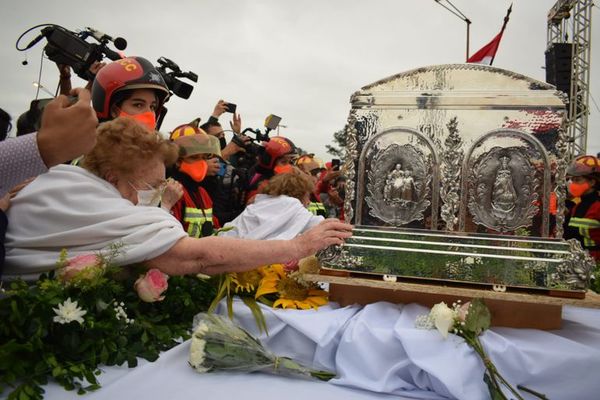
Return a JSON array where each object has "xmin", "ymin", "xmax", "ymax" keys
[{"xmin": 4, "ymin": 118, "xmax": 351, "ymax": 279}]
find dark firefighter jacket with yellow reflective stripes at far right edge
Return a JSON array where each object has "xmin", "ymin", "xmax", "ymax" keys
[{"xmin": 564, "ymin": 192, "xmax": 600, "ymax": 262}]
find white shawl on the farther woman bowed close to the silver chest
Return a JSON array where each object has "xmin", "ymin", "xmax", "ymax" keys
[{"xmin": 219, "ymin": 194, "xmax": 323, "ymax": 239}]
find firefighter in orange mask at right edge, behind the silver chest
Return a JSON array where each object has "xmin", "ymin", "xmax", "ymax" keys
[{"xmin": 564, "ymin": 155, "xmax": 600, "ymax": 262}]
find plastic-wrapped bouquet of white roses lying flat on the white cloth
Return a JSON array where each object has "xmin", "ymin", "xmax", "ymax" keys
[{"xmin": 189, "ymin": 313, "xmax": 335, "ymax": 381}]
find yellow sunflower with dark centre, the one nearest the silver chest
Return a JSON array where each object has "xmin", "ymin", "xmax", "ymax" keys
[{"xmin": 255, "ymin": 264, "xmax": 327, "ymax": 310}]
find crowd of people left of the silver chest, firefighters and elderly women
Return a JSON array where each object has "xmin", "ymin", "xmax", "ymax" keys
[{"xmin": 0, "ymin": 57, "xmax": 352, "ymax": 279}]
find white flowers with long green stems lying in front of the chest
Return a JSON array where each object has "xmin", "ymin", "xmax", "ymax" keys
[{"xmin": 415, "ymin": 299, "xmax": 547, "ymax": 400}]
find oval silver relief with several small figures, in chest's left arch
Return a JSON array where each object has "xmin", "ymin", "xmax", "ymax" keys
[{"xmin": 365, "ymin": 143, "xmax": 431, "ymax": 226}]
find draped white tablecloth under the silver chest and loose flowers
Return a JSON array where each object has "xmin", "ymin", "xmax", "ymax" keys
[{"xmin": 37, "ymin": 302, "xmax": 600, "ymax": 400}]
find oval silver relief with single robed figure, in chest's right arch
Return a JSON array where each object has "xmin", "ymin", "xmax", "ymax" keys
[{"xmin": 468, "ymin": 147, "xmax": 539, "ymax": 232}]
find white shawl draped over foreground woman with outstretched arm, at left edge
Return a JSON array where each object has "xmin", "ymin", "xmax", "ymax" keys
[{"xmin": 4, "ymin": 165, "xmax": 187, "ymax": 279}]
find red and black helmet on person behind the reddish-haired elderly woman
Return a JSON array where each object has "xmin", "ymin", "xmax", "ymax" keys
[{"xmin": 92, "ymin": 57, "xmax": 170, "ymax": 120}]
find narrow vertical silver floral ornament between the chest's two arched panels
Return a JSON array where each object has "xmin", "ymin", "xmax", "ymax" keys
[{"xmin": 440, "ymin": 117, "xmax": 464, "ymax": 231}]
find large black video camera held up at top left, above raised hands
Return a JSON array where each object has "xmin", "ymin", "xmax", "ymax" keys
[{"xmin": 16, "ymin": 24, "xmax": 127, "ymax": 80}]
